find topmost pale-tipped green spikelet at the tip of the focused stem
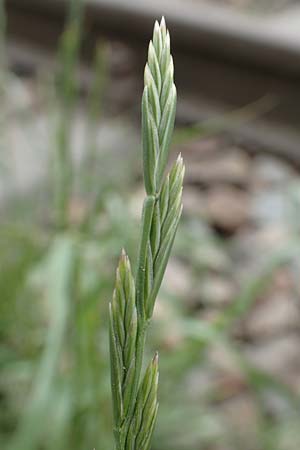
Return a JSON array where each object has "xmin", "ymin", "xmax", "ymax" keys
[{"xmin": 142, "ymin": 18, "xmax": 177, "ymax": 195}]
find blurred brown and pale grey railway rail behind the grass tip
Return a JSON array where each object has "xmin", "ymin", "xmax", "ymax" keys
[{"xmin": 7, "ymin": 0, "xmax": 300, "ymax": 166}]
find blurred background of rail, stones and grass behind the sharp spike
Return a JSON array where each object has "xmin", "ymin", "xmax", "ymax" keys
[{"xmin": 0, "ymin": 0, "xmax": 300, "ymax": 450}]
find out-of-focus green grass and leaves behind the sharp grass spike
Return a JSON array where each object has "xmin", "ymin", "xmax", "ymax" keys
[{"xmin": 0, "ymin": 2, "xmax": 300, "ymax": 450}]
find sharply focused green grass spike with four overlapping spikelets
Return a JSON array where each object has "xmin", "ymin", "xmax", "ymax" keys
[{"xmin": 110, "ymin": 18, "xmax": 184, "ymax": 450}]
